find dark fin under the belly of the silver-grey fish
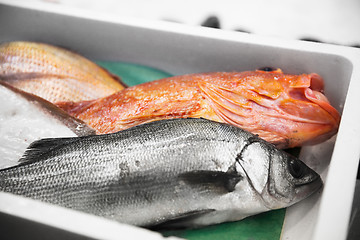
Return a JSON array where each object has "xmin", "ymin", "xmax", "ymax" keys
[{"xmin": 144, "ymin": 209, "xmax": 216, "ymax": 230}]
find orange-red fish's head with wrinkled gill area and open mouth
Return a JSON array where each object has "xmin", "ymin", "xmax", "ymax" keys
[{"xmin": 200, "ymin": 69, "xmax": 340, "ymax": 148}]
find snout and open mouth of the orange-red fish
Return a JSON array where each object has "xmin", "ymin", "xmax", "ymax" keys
[{"xmin": 279, "ymin": 73, "xmax": 341, "ymax": 147}]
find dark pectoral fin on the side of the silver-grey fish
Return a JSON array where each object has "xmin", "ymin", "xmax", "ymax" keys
[{"xmin": 179, "ymin": 167, "xmax": 243, "ymax": 192}]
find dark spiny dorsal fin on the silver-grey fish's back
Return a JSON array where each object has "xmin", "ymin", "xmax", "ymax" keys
[{"xmin": 19, "ymin": 137, "xmax": 78, "ymax": 164}]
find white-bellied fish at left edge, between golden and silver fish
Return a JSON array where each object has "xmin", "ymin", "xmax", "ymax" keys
[{"xmin": 0, "ymin": 81, "xmax": 95, "ymax": 168}]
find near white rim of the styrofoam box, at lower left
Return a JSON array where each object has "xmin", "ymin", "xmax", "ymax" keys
[{"xmin": 0, "ymin": 192, "xmax": 180, "ymax": 240}]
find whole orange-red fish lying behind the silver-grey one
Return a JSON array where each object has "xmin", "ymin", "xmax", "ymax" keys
[{"xmin": 56, "ymin": 69, "xmax": 340, "ymax": 149}]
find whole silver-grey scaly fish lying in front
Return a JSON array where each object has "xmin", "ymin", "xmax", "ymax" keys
[{"xmin": 0, "ymin": 118, "xmax": 323, "ymax": 229}]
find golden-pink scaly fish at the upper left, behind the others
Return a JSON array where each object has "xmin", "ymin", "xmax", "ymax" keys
[{"xmin": 0, "ymin": 41, "xmax": 126, "ymax": 103}]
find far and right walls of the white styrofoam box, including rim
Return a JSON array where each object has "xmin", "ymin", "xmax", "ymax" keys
[{"xmin": 0, "ymin": 1, "xmax": 360, "ymax": 240}]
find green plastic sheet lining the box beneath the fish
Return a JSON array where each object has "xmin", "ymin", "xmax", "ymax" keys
[{"xmin": 97, "ymin": 61, "xmax": 285, "ymax": 240}]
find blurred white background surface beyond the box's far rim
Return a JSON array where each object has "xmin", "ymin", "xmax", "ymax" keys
[{"xmin": 21, "ymin": 0, "xmax": 360, "ymax": 45}]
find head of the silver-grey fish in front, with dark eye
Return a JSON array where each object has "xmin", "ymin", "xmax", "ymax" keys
[{"xmin": 238, "ymin": 139, "xmax": 323, "ymax": 209}]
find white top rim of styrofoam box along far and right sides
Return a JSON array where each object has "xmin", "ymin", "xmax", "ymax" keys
[{"xmin": 0, "ymin": 1, "xmax": 360, "ymax": 239}]
